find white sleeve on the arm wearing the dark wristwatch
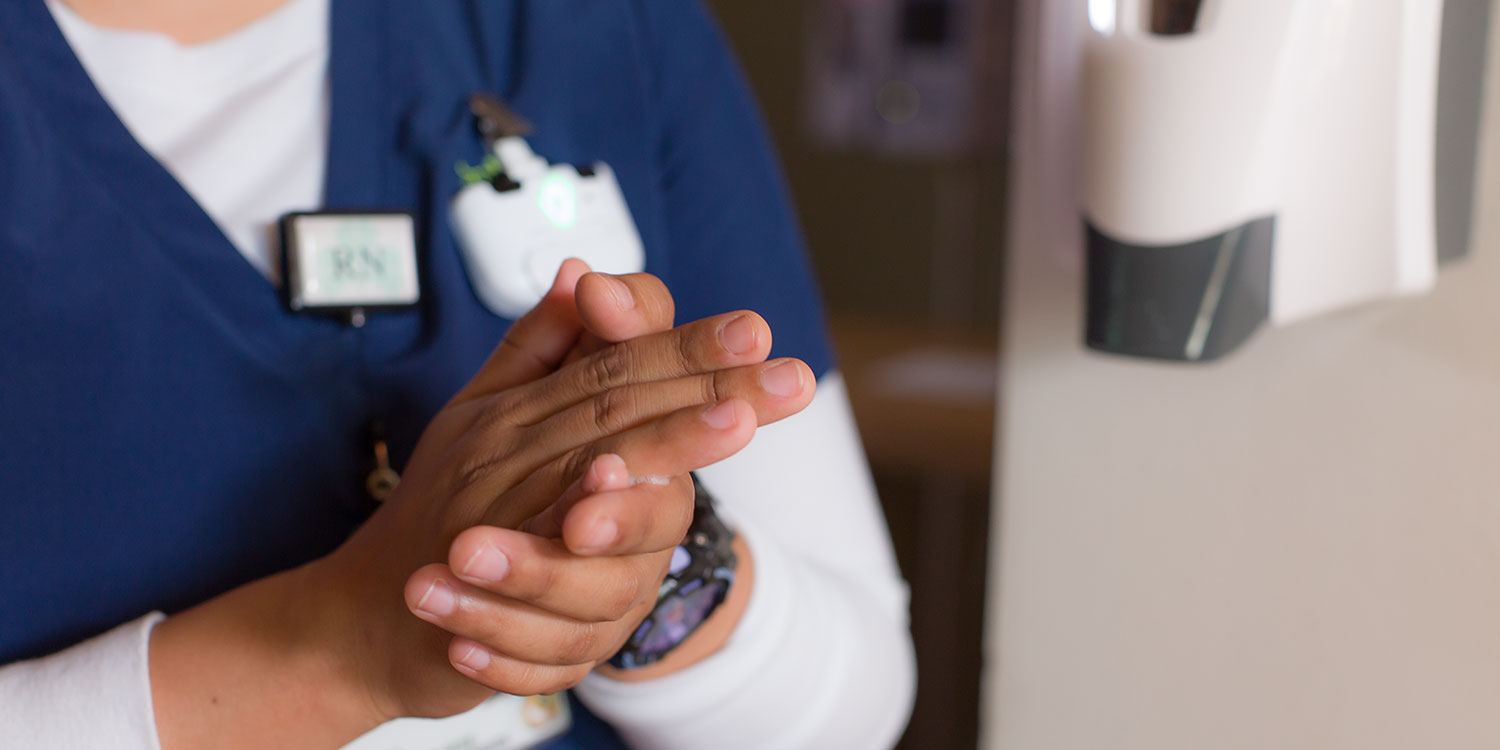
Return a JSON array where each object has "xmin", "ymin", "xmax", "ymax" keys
[{"xmin": 579, "ymin": 374, "xmax": 915, "ymax": 749}]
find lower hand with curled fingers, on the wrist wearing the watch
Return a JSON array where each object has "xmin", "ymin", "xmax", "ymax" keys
[{"xmin": 407, "ymin": 450, "xmax": 696, "ymax": 695}]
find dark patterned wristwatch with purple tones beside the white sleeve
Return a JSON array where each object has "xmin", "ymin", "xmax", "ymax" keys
[{"xmin": 609, "ymin": 476, "xmax": 740, "ymax": 669}]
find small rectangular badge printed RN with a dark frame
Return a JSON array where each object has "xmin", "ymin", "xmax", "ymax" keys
[{"xmin": 281, "ymin": 212, "xmax": 422, "ymax": 320}]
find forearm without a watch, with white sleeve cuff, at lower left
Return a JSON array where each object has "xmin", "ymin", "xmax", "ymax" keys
[{"xmin": 0, "ymin": 569, "xmax": 380, "ymax": 750}]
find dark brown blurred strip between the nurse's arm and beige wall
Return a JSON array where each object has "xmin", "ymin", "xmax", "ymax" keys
[{"xmin": 710, "ymin": 0, "xmax": 1011, "ymax": 749}]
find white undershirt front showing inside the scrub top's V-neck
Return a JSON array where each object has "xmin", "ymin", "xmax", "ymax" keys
[{"xmin": 47, "ymin": 0, "xmax": 330, "ymax": 281}]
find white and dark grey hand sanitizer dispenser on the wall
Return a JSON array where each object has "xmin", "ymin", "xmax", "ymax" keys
[{"xmin": 1086, "ymin": 0, "xmax": 1490, "ymax": 362}]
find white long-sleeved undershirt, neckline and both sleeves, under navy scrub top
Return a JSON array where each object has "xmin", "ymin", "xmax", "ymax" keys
[{"xmin": 11, "ymin": 0, "xmax": 915, "ymax": 750}]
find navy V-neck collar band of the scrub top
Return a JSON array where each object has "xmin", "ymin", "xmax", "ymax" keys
[{"xmin": 0, "ymin": 0, "xmax": 390, "ymax": 371}]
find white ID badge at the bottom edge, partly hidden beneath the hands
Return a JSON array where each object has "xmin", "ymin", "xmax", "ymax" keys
[{"xmin": 344, "ymin": 693, "xmax": 573, "ymax": 750}]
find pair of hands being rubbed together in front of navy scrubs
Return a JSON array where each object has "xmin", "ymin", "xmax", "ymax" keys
[{"xmin": 320, "ymin": 261, "xmax": 815, "ymax": 719}]
